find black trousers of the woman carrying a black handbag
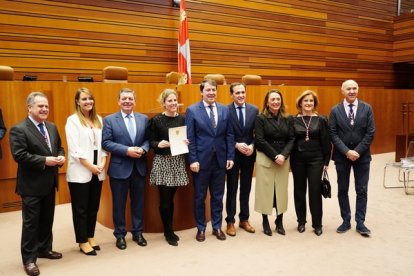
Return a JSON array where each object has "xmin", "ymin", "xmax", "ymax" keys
[{"xmin": 290, "ymin": 152, "xmax": 324, "ymax": 228}]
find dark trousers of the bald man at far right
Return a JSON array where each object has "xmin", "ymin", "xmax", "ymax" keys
[{"xmin": 335, "ymin": 158, "xmax": 370, "ymax": 224}]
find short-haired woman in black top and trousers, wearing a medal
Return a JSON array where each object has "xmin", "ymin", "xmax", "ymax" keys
[{"xmin": 290, "ymin": 90, "xmax": 330, "ymax": 236}]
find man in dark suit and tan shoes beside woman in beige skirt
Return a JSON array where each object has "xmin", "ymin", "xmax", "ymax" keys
[{"xmin": 226, "ymin": 82, "xmax": 259, "ymax": 236}]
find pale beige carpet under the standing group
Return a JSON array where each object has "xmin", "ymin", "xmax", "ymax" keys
[{"xmin": 0, "ymin": 153, "xmax": 414, "ymax": 276}]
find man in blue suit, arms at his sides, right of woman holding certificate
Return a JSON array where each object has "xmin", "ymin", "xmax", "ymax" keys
[{"xmin": 185, "ymin": 80, "xmax": 234, "ymax": 242}]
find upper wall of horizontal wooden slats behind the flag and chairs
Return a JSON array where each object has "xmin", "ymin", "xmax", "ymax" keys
[{"xmin": 0, "ymin": 0, "xmax": 406, "ymax": 87}]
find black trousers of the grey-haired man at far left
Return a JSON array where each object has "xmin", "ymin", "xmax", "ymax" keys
[{"xmin": 21, "ymin": 188, "xmax": 55, "ymax": 264}]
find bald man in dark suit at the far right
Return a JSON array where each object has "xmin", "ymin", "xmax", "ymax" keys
[{"xmin": 329, "ymin": 80, "xmax": 375, "ymax": 236}]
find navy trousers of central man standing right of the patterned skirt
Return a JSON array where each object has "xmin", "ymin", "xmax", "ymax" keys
[{"xmin": 193, "ymin": 155, "xmax": 226, "ymax": 231}]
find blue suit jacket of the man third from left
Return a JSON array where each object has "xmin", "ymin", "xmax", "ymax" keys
[{"xmin": 102, "ymin": 112, "xmax": 149, "ymax": 179}]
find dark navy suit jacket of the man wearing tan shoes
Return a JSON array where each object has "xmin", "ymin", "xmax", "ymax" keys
[{"xmin": 227, "ymin": 103, "xmax": 259, "ymax": 161}]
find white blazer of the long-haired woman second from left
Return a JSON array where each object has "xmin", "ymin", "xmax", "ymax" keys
[{"xmin": 65, "ymin": 114, "xmax": 107, "ymax": 183}]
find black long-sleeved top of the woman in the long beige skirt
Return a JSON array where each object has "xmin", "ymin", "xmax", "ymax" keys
[{"xmin": 255, "ymin": 114, "xmax": 295, "ymax": 160}]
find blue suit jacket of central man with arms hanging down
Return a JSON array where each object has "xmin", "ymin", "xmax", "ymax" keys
[{"xmin": 185, "ymin": 101, "xmax": 234, "ymax": 169}]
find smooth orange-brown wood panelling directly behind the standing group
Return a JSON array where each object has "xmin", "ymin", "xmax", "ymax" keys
[{"xmin": 0, "ymin": 81, "xmax": 414, "ymax": 212}]
